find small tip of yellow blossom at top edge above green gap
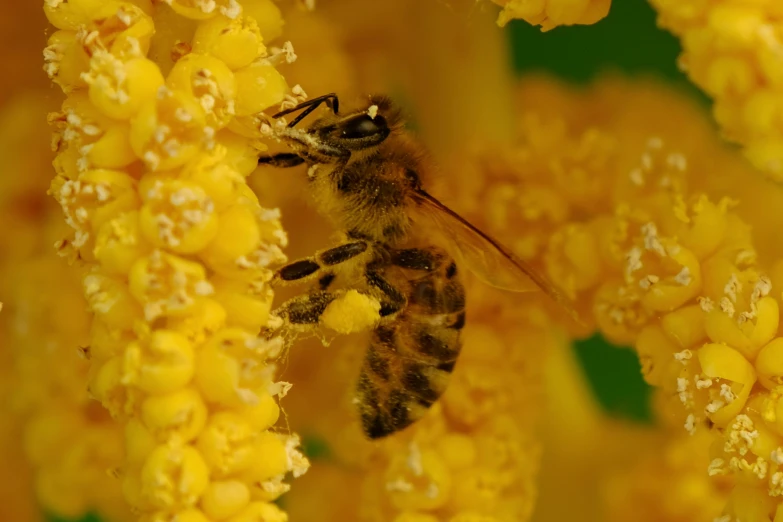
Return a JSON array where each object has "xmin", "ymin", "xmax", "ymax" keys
[{"xmin": 492, "ymin": 0, "xmax": 612, "ymax": 31}]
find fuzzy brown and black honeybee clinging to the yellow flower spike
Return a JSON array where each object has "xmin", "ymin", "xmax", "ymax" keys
[{"xmin": 259, "ymin": 94, "xmax": 565, "ymax": 439}]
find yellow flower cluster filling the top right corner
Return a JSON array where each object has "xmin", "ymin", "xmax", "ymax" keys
[{"xmin": 651, "ymin": 0, "xmax": 783, "ymax": 181}]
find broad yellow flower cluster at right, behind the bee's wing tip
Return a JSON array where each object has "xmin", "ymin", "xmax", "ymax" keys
[{"xmin": 454, "ymin": 76, "xmax": 783, "ymax": 520}]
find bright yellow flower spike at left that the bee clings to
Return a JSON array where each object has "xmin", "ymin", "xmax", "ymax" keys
[{"xmin": 44, "ymin": 0, "xmax": 308, "ymax": 522}]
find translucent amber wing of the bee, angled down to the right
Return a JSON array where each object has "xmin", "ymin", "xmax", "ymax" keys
[{"xmin": 414, "ymin": 190, "xmax": 574, "ymax": 315}]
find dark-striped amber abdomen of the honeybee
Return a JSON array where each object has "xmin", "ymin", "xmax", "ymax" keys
[{"xmin": 358, "ymin": 263, "xmax": 465, "ymax": 439}]
